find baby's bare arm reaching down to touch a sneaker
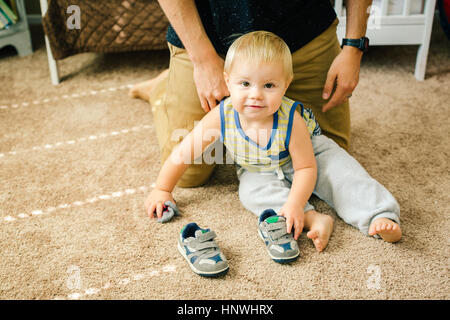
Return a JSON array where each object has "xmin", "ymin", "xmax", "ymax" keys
[{"xmin": 280, "ymin": 111, "xmax": 317, "ymax": 240}]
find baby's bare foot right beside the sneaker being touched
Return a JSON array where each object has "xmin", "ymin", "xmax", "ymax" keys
[{"xmin": 305, "ymin": 210, "xmax": 333, "ymax": 252}]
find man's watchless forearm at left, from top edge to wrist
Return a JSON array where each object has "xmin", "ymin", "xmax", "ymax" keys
[{"xmin": 158, "ymin": 0, "xmax": 217, "ymax": 63}]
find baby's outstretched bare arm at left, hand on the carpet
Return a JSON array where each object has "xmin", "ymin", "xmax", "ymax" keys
[{"xmin": 145, "ymin": 107, "xmax": 220, "ymax": 218}]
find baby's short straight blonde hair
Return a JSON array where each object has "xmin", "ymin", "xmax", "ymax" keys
[{"xmin": 224, "ymin": 31, "xmax": 293, "ymax": 80}]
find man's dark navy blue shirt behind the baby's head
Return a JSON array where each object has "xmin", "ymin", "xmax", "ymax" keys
[{"xmin": 166, "ymin": 0, "xmax": 336, "ymax": 54}]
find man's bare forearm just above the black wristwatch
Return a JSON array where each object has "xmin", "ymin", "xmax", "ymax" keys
[{"xmin": 345, "ymin": 0, "xmax": 372, "ymax": 39}]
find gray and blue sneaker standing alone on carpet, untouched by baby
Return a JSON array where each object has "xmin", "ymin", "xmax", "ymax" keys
[{"xmin": 178, "ymin": 222, "xmax": 228, "ymax": 277}]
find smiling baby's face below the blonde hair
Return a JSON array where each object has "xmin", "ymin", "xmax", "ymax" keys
[{"xmin": 224, "ymin": 60, "xmax": 290, "ymax": 121}]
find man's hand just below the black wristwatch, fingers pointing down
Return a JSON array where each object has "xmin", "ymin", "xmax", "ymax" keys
[{"xmin": 322, "ymin": 46, "xmax": 362, "ymax": 112}]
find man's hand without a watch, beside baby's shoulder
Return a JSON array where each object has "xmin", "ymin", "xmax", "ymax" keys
[{"xmin": 194, "ymin": 54, "xmax": 230, "ymax": 112}]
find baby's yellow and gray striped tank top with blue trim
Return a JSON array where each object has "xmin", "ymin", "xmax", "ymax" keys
[{"xmin": 220, "ymin": 97, "xmax": 321, "ymax": 172}]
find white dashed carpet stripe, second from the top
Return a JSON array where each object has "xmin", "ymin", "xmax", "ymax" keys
[{"xmin": 0, "ymin": 124, "xmax": 153, "ymax": 158}]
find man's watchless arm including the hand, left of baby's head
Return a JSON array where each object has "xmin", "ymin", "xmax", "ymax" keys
[{"xmin": 159, "ymin": 0, "xmax": 229, "ymax": 112}]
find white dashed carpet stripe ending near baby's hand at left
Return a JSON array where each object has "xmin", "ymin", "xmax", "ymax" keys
[{"xmin": 3, "ymin": 184, "xmax": 149, "ymax": 222}]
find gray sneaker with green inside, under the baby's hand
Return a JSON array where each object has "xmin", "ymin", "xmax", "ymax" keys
[{"xmin": 258, "ymin": 209, "xmax": 300, "ymax": 263}]
